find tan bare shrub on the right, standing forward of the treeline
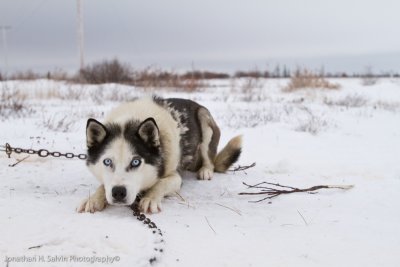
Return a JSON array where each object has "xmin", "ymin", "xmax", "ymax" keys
[{"xmin": 283, "ymin": 68, "xmax": 340, "ymax": 92}]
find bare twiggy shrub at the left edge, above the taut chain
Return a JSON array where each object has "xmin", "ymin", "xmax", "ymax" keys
[{"xmin": 0, "ymin": 86, "xmax": 32, "ymax": 119}]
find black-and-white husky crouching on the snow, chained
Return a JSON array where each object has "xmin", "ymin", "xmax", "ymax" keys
[{"xmin": 77, "ymin": 97, "xmax": 242, "ymax": 213}]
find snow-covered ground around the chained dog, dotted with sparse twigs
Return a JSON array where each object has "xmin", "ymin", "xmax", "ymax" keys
[{"xmin": 0, "ymin": 79, "xmax": 400, "ymax": 266}]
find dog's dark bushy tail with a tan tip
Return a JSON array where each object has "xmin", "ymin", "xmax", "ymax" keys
[{"xmin": 214, "ymin": 135, "xmax": 242, "ymax": 172}]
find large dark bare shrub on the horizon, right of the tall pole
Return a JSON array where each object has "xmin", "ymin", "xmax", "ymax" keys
[{"xmin": 78, "ymin": 59, "xmax": 132, "ymax": 84}]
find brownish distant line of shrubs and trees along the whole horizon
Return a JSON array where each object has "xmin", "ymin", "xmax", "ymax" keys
[{"xmin": 0, "ymin": 59, "xmax": 400, "ymax": 82}]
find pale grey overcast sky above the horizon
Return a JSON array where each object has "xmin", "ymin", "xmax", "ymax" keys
[{"xmin": 0, "ymin": 0, "xmax": 400, "ymax": 72}]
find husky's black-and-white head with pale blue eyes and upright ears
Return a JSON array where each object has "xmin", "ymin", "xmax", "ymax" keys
[{"xmin": 86, "ymin": 118, "xmax": 163, "ymax": 205}]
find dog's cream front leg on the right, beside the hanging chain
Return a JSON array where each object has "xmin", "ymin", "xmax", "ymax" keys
[{"xmin": 139, "ymin": 172, "xmax": 182, "ymax": 213}]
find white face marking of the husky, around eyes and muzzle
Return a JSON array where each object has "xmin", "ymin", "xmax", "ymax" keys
[{"xmin": 89, "ymin": 137, "xmax": 157, "ymax": 205}]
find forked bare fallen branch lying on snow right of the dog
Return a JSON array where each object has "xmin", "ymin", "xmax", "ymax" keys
[{"xmin": 239, "ymin": 182, "xmax": 354, "ymax": 203}]
